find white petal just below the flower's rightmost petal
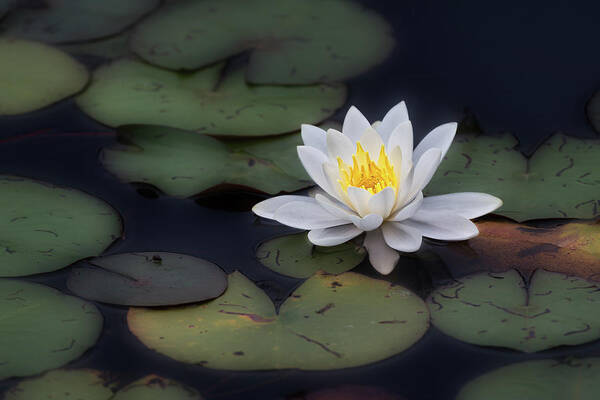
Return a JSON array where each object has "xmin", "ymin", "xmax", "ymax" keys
[{"xmin": 402, "ymin": 209, "xmax": 479, "ymax": 240}]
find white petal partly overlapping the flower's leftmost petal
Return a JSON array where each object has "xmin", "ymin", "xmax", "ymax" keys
[{"xmin": 273, "ymin": 202, "xmax": 348, "ymax": 229}]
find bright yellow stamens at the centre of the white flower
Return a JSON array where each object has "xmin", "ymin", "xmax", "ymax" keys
[{"xmin": 337, "ymin": 142, "xmax": 398, "ymax": 194}]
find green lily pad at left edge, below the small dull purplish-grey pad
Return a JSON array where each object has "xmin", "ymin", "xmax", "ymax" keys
[{"xmin": 0, "ymin": 278, "xmax": 102, "ymax": 380}]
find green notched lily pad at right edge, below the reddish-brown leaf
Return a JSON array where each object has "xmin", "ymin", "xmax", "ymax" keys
[{"xmin": 427, "ymin": 270, "xmax": 600, "ymax": 352}]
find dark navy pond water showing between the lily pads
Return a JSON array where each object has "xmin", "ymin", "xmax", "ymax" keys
[{"xmin": 0, "ymin": 1, "xmax": 600, "ymax": 400}]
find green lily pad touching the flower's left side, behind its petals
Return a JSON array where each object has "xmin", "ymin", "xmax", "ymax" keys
[{"xmin": 100, "ymin": 126, "xmax": 314, "ymax": 197}]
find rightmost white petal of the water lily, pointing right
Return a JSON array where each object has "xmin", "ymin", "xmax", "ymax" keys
[{"xmin": 422, "ymin": 192, "xmax": 502, "ymax": 219}]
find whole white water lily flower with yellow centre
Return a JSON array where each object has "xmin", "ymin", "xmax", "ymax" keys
[{"xmin": 252, "ymin": 102, "xmax": 502, "ymax": 274}]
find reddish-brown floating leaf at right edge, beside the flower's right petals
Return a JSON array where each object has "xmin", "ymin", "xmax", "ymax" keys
[{"xmin": 439, "ymin": 221, "xmax": 600, "ymax": 281}]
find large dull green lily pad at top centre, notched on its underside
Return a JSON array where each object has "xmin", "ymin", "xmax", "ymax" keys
[{"xmin": 131, "ymin": 0, "xmax": 394, "ymax": 84}]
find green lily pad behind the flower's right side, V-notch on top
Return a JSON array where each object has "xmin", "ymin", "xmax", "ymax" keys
[{"xmin": 426, "ymin": 134, "xmax": 600, "ymax": 222}]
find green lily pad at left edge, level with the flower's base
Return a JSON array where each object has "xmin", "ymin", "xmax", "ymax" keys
[{"xmin": 0, "ymin": 175, "xmax": 122, "ymax": 276}]
